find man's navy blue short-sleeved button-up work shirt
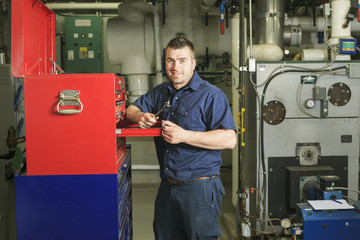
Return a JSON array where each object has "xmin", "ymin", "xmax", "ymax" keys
[{"xmin": 133, "ymin": 71, "xmax": 236, "ymax": 181}]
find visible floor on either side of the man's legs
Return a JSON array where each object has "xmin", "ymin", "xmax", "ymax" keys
[{"xmin": 132, "ymin": 170, "xmax": 238, "ymax": 240}]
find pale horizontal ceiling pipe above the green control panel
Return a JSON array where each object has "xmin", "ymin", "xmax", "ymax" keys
[{"xmin": 45, "ymin": 2, "xmax": 121, "ymax": 11}]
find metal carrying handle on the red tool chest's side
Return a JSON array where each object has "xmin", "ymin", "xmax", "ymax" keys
[{"xmin": 56, "ymin": 90, "xmax": 84, "ymax": 115}]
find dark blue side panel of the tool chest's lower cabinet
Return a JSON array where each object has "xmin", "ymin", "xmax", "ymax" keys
[{"xmin": 15, "ymin": 174, "xmax": 121, "ymax": 240}]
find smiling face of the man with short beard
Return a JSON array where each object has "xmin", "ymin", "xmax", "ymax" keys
[{"xmin": 166, "ymin": 47, "xmax": 196, "ymax": 89}]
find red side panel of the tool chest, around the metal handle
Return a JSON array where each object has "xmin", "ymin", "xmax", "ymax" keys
[{"xmin": 24, "ymin": 74, "xmax": 121, "ymax": 175}]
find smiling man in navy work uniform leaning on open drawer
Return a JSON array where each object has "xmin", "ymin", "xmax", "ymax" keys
[{"xmin": 126, "ymin": 37, "xmax": 236, "ymax": 240}]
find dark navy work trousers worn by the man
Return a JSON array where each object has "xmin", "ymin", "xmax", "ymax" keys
[{"xmin": 154, "ymin": 177, "xmax": 225, "ymax": 240}]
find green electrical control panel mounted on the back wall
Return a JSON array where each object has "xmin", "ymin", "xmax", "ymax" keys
[{"xmin": 64, "ymin": 16, "xmax": 102, "ymax": 73}]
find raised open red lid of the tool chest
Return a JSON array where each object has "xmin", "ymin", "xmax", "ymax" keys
[{"xmin": 11, "ymin": 0, "xmax": 55, "ymax": 77}]
